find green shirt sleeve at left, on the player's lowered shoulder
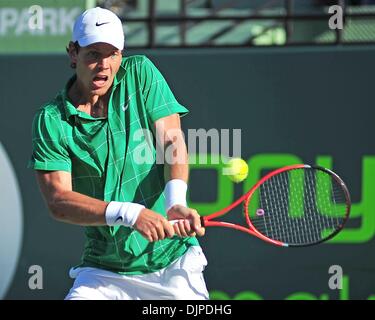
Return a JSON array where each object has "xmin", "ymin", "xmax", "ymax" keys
[{"xmin": 28, "ymin": 110, "xmax": 72, "ymax": 172}]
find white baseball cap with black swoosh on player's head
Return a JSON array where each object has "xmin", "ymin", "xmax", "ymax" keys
[{"xmin": 72, "ymin": 7, "xmax": 124, "ymax": 50}]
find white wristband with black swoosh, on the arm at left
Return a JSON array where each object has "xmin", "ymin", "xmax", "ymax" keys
[{"xmin": 105, "ymin": 201, "xmax": 145, "ymax": 227}]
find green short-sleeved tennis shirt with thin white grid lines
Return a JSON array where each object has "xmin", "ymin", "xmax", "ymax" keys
[{"xmin": 29, "ymin": 56, "xmax": 198, "ymax": 274}]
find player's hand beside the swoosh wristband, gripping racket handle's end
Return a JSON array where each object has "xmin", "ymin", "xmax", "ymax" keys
[{"xmin": 133, "ymin": 208, "xmax": 174, "ymax": 242}]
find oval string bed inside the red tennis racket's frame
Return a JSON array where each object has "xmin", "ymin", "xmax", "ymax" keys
[{"xmin": 249, "ymin": 168, "xmax": 347, "ymax": 244}]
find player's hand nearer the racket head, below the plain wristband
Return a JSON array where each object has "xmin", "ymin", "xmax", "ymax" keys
[{"xmin": 167, "ymin": 204, "xmax": 205, "ymax": 237}]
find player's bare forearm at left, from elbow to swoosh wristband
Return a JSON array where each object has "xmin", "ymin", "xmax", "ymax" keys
[{"xmin": 48, "ymin": 191, "xmax": 108, "ymax": 226}]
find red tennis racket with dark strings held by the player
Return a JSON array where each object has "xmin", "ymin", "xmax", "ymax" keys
[{"xmin": 175, "ymin": 164, "xmax": 351, "ymax": 247}]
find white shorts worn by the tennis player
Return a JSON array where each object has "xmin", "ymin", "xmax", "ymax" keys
[{"xmin": 65, "ymin": 246, "xmax": 208, "ymax": 300}]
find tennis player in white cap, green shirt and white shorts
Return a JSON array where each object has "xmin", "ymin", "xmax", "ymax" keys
[{"xmin": 29, "ymin": 8, "xmax": 208, "ymax": 300}]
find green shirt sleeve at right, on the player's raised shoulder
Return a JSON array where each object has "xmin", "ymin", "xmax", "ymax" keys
[{"xmin": 140, "ymin": 57, "xmax": 189, "ymax": 122}]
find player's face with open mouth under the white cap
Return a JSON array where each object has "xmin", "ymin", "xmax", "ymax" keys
[{"xmin": 76, "ymin": 43, "xmax": 122, "ymax": 96}]
